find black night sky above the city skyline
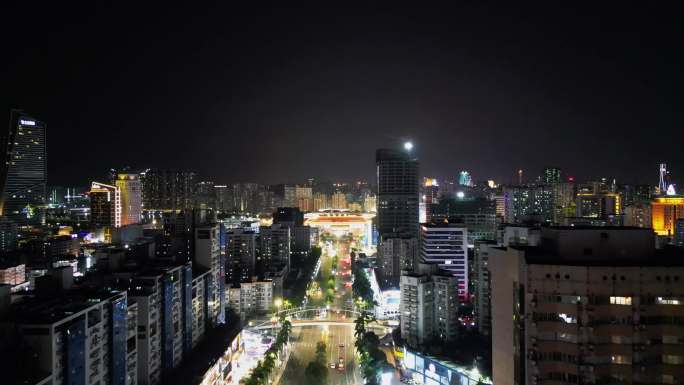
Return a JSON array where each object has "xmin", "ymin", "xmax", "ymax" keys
[{"xmin": 0, "ymin": 1, "xmax": 684, "ymax": 184}]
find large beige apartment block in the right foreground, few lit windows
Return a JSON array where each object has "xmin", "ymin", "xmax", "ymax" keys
[{"xmin": 487, "ymin": 227, "xmax": 684, "ymax": 385}]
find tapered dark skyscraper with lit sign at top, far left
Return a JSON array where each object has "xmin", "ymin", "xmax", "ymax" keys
[{"xmin": 0, "ymin": 110, "xmax": 47, "ymax": 226}]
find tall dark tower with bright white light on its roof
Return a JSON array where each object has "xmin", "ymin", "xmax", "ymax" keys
[{"xmin": 375, "ymin": 143, "xmax": 419, "ymax": 237}]
